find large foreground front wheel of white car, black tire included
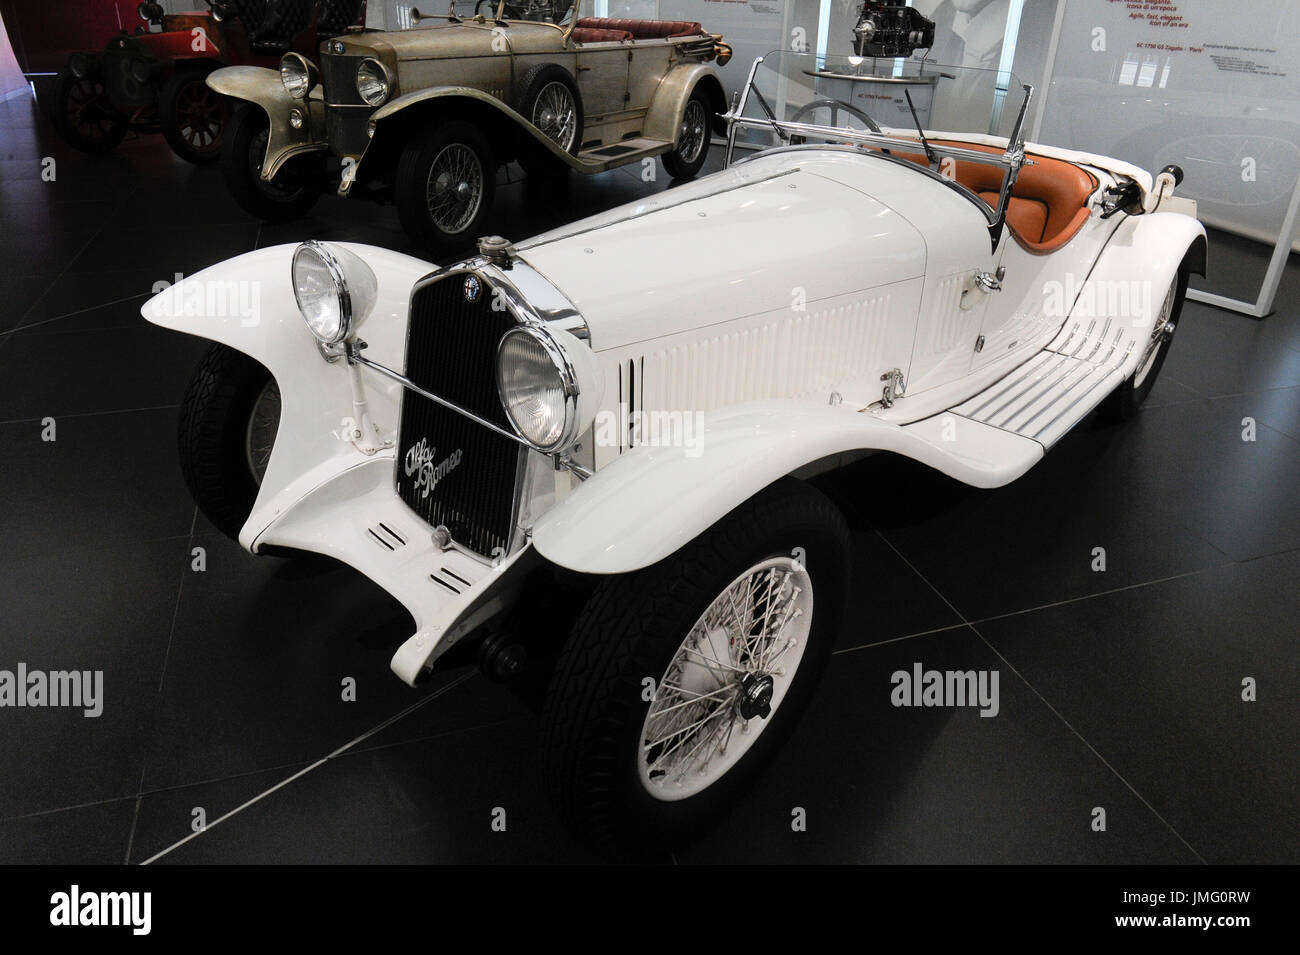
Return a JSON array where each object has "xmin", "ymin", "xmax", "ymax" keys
[{"xmin": 542, "ymin": 478, "xmax": 850, "ymax": 852}]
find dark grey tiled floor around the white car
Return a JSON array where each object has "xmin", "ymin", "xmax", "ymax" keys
[{"xmin": 0, "ymin": 91, "xmax": 1300, "ymax": 863}]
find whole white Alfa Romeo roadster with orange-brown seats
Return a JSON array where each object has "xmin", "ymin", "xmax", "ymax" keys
[{"xmin": 143, "ymin": 52, "xmax": 1206, "ymax": 842}]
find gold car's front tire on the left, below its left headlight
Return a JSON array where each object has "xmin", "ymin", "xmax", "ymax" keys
[{"xmin": 221, "ymin": 103, "xmax": 325, "ymax": 222}]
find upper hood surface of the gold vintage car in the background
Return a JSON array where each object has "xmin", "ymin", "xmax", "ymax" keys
[{"xmin": 330, "ymin": 18, "xmax": 563, "ymax": 62}]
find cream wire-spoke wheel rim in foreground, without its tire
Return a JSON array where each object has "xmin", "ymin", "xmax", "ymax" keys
[{"xmin": 637, "ymin": 557, "xmax": 813, "ymax": 802}]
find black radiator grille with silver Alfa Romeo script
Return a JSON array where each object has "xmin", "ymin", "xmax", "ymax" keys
[{"xmin": 397, "ymin": 272, "xmax": 527, "ymax": 557}]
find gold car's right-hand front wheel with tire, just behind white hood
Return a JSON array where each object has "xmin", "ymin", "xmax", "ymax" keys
[{"xmin": 394, "ymin": 121, "xmax": 497, "ymax": 251}]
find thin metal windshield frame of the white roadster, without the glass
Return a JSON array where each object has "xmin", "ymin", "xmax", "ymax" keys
[{"xmin": 723, "ymin": 51, "xmax": 1034, "ymax": 251}]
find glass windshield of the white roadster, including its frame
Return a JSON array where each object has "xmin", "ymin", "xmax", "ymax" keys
[{"xmin": 727, "ymin": 51, "xmax": 1032, "ymax": 237}]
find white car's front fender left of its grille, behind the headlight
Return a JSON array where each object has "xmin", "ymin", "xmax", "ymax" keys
[{"xmin": 140, "ymin": 243, "xmax": 433, "ymax": 551}]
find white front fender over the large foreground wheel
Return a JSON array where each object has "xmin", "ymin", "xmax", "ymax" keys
[{"xmin": 532, "ymin": 400, "xmax": 1043, "ymax": 574}]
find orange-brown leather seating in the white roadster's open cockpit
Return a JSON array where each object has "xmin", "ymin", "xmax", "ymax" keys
[{"xmin": 894, "ymin": 140, "xmax": 1097, "ymax": 255}]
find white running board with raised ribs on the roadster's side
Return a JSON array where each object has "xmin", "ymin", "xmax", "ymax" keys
[{"xmin": 950, "ymin": 318, "xmax": 1138, "ymax": 448}]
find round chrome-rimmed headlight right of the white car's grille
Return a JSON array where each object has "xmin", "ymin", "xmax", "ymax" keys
[{"xmin": 497, "ymin": 326, "xmax": 577, "ymax": 451}]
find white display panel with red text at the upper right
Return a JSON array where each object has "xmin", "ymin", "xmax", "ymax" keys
[{"xmin": 1037, "ymin": 0, "xmax": 1300, "ymax": 312}]
